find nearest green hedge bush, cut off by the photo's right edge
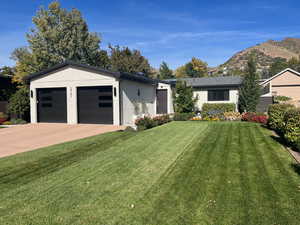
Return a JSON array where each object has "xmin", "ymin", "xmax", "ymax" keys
[{"xmin": 283, "ymin": 109, "xmax": 300, "ymax": 150}]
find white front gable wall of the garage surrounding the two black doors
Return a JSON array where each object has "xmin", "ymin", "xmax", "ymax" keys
[{"xmin": 30, "ymin": 67, "xmax": 120, "ymax": 125}]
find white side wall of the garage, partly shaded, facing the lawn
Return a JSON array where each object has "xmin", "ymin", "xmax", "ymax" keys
[{"xmin": 120, "ymin": 80, "xmax": 156, "ymax": 126}]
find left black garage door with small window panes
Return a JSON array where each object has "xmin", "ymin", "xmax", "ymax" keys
[{"xmin": 37, "ymin": 88, "xmax": 67, "ymax": 123}]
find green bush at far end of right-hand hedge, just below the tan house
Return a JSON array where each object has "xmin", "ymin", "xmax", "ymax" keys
[{"xmin": 268, "ymin": 104, "xmax": 294, "ymax": 134}]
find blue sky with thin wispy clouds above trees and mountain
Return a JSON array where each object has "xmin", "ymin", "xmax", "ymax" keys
[{"xmin": 0, "ymin": 0, "xmax": 300, "ymax": 68}]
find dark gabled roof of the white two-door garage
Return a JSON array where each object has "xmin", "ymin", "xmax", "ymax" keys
[{"xmin": 25, "ymin": 61, "xmax": 161, "ymax": 84}]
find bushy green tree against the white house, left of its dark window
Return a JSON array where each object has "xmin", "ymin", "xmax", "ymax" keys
[{"xmin": 175, "ymin": 80, "xmax": 197, "ymax": 113}]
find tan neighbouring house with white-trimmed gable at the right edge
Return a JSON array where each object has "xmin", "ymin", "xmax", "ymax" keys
[{"xmin": 261, "ymin": 68, "xmax": 300, "ymax": 105}]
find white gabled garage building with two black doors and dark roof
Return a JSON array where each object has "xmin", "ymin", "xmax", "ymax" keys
[{"xmin": 26, "ymin": 61, "xmax": 173, "ymax": 126}]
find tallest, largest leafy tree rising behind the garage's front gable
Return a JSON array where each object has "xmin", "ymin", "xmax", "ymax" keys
[{"xmin": 12, "ymin": 1, "xmax": 109, "ymax": 82}]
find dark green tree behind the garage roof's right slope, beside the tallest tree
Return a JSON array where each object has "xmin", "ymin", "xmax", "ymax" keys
[{"xmin": 109, "ymin": 45, "xmax": 152, "ymax": 76}]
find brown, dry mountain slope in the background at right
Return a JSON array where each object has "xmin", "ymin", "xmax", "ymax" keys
[{"xmin": 215, "ymin": 38, "xmax": 300, "ymax": 74}]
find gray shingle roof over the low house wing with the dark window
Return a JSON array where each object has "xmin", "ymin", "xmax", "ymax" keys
[{"xmin": 166, "ymin": 76, "xmax": 243, "ymax": 87}]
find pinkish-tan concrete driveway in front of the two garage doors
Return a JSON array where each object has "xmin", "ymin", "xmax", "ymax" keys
[{"xmin": 0, "ymin": 123, "xmax": 123, "ymax": 157}]
